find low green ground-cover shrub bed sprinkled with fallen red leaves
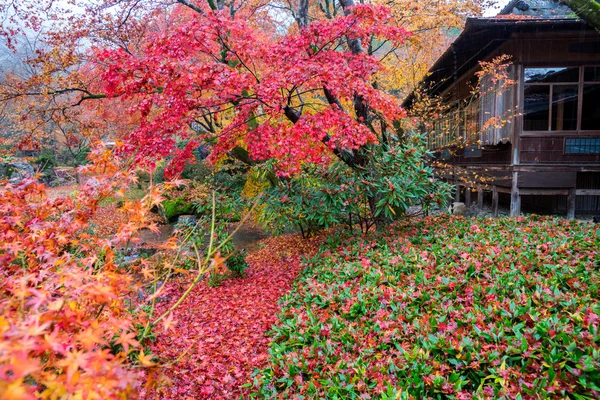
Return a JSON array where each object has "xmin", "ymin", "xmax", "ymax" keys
[{"xmin": 254, "ymin": 217, "xmax": 600, "ymax": 399}]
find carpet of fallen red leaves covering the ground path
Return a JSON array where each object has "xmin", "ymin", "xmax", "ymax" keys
[{"xmin": 147, "ymin": 235, "xmax": 322, "ymax": 399}]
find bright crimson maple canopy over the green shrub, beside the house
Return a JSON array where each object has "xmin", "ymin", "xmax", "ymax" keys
[{"xmin": 98, "ymin": 1, "xmax": 408, "ymax": 174}]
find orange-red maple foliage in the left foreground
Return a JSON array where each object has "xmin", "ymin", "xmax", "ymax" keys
[{"xmin": 0, "ymin": 154, "xmax": 148, "ymax": 399}]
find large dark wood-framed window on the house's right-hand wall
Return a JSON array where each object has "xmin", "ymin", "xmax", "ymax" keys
[{"xmin": 523, "ymin": 66, "xmax": 600, "ymax": 131}]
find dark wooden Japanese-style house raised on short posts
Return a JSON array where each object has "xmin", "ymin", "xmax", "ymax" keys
[{"xmin": 403, "ymin": 0, "xmax": 600, "ymax": 218}]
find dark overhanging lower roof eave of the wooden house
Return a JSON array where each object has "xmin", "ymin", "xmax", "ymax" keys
[{"xmin": 402, "ymin": 16, "xmax": 593, "ymax": 108}]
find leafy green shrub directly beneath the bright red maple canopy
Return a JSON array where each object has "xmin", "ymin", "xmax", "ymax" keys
[{"xmin": 252, "ymin": 135, "xmax": 450, "ymax": 236}]
